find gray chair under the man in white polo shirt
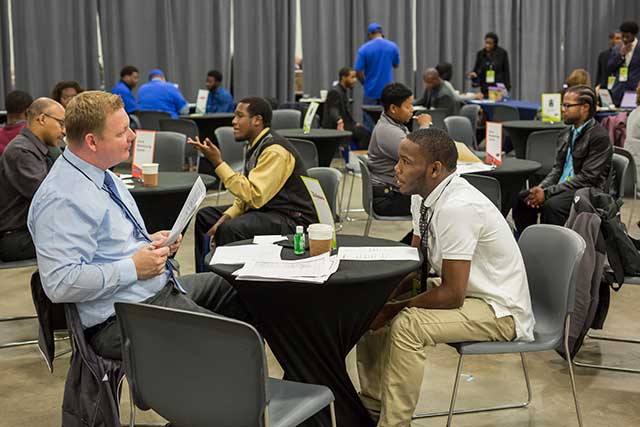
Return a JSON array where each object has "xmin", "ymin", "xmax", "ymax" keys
[{"xmin": 414, "ymin": 224, "xmax": 586, "ymax": 426}]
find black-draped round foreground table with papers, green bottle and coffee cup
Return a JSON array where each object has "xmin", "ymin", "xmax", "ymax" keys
[{"xmin": 207, "ymin": 235, "xmax": 420, "ymax": 427}]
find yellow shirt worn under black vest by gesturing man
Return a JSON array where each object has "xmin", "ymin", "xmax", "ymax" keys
[{"xmin": 216, "ymin": 128, "xmax": 296, "ymax": 218}]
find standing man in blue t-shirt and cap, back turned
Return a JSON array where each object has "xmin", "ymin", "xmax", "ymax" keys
[{"xmin": 354, "ymin": 22, "xmax": 400, "ymax": 130}]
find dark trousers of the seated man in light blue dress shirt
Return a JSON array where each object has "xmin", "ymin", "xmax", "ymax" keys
[{"xmin": 85, "ymin": 273, "xmax": 250, "ymax": 360}]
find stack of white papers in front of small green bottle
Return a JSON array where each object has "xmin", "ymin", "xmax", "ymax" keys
[{"xmin": 233, "ymin": 254, "xmax": 340, "ymax": 283}]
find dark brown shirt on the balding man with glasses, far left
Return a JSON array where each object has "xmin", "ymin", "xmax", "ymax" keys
[{"xmin": 0, "ymin": 127, "xmax": 52, "ymax": 232}]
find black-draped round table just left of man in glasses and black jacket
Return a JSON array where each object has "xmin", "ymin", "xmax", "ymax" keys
[{"xmin": 464, "ymin": 157, "xmax": 542, "ymax": 216}]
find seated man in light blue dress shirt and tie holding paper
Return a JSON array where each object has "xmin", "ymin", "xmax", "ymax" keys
[{"xmin": 28, "ymin": 91, "xmax": 247, "ymax": 359}]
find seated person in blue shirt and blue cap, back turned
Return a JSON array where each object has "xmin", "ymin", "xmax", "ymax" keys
[{"xmin": 138, "ymin": 68, "xmax": 189, "ymax": 119}]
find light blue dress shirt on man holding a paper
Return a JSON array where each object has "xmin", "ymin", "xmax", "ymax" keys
[{"xmin": 28, "ymin": 149, "xmax": 169, "ymax": 328}]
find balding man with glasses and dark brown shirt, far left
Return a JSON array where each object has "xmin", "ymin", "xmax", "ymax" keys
[{"xmin": 0, "ymin": 98, "xmax": 65, "ymax": 262}]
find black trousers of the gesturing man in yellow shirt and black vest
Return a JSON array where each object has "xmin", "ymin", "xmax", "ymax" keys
[{"xmin": 195, "ymin": 207, "xmax": 305, "ymax": 273}]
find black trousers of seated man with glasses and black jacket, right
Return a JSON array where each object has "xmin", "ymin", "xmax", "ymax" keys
[{"xmin": 512, "ymin": 190, "xmax": 575, "ymax": 235}]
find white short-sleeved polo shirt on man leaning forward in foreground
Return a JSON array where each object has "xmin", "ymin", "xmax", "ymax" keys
[{"xmin": 411, "ymin": 173, "xmax": 535, "ymax": 341}]
